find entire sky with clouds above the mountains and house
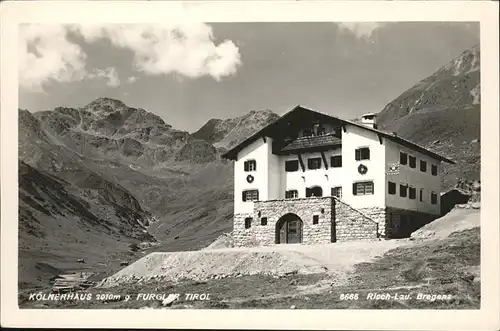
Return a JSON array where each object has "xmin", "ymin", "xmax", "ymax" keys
[{"xmin": 18, "ymin": 22, "xmax": 479, "ymax": 132}]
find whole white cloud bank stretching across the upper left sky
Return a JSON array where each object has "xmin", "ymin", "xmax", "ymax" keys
[{"xmin": 19, "ymin": 23, "xmax": 241, "ymax": 91}]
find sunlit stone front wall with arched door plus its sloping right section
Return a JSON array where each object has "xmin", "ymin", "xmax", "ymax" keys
[{"xmin": 233, "ymin": 197, "xmax": 380, "ymax": 247}]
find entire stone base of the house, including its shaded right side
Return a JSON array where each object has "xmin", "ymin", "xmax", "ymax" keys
[{"xmin": 233, "ymin": 197, "xmax": 439, "ymax": 247}]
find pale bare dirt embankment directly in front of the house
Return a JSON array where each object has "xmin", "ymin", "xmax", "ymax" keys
[{"xmin": 101, "ymin": 240, "xmax": 411, "ymax": 287}]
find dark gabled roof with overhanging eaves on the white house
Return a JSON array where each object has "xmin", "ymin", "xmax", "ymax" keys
[{"xmin": 222, "ymin": 105, "xmax": 455, "ymax": 164}]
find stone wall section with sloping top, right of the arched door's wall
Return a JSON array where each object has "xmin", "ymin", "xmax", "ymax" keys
[{"xmin": 335, "ymin": 200, "xmax": 378, "ymax": 241}]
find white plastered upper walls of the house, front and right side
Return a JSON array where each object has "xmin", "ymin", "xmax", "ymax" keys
[{"xmin": 234, "ymin": 125, "xmax": 440, "ymax": 215}]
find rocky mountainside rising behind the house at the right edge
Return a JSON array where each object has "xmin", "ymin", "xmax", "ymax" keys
[{"xmin": 378, "ymin": 46, "xmax": 481, "ymax": 189}]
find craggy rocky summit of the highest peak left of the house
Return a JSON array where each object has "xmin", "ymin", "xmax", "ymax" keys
[{"xmin": 34, "ymin": 98, "xmax": 216, "ymax": 166}]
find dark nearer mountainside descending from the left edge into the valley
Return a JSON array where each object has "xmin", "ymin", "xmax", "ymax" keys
[{"xmin": 18, "ymin": 110, "xmax": 160, "ymax": 286}]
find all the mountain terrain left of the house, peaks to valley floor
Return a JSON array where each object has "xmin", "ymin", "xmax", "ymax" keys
[{"xmin": 19, "ymin": 98, "xmax": 273, "ymax": 286}]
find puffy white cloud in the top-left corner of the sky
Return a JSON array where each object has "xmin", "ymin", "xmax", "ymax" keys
[{"xmin": 19, "ymin": 24, "xmax": 87, "ymax": 91}]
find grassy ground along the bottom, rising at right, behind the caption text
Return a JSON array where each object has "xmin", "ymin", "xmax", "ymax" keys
[{"xmin": 20, "ymin": 228, "xmax": 480, "ymax": 309}]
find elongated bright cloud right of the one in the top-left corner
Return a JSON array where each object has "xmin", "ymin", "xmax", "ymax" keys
[{"xmin": 72, "ymin": 23, "xmax": 241, "ymax": 80}]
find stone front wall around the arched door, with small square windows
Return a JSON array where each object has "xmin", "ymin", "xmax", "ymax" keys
[{"xmin": 233, "ymin": 197, "xmax": 335, "ymax": 246}]
